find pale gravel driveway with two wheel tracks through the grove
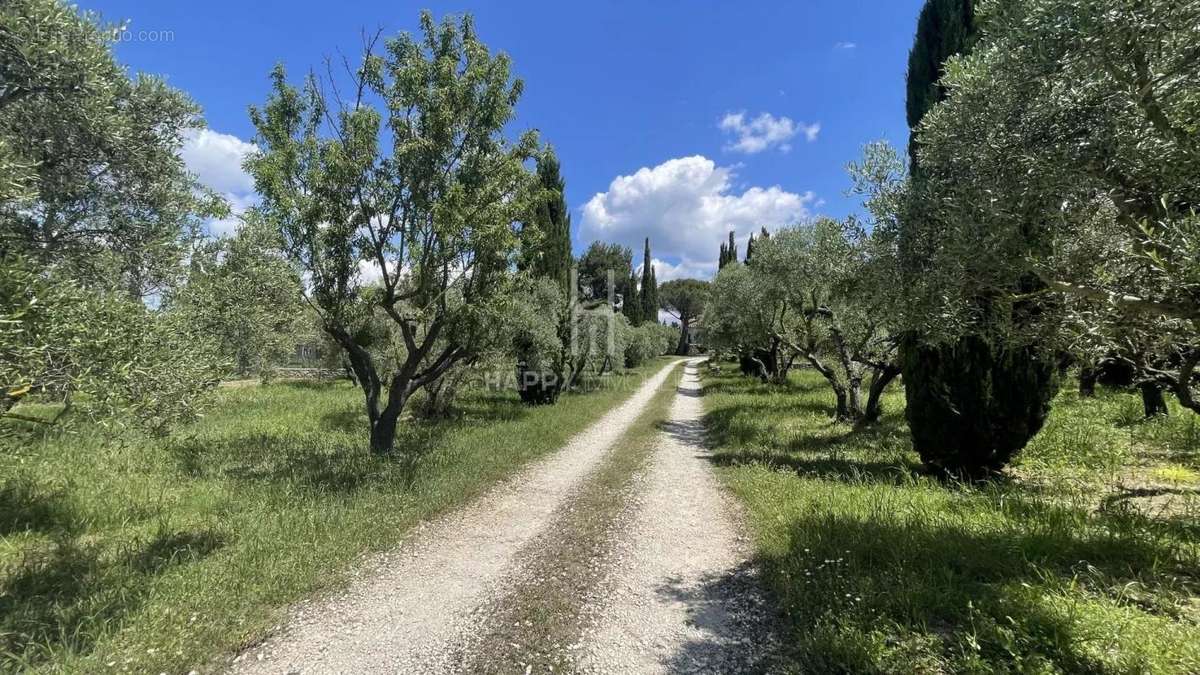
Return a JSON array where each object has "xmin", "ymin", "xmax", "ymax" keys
[{"xmin": 233, "ymin": 360, "xmax": 778, "ymax": 675}]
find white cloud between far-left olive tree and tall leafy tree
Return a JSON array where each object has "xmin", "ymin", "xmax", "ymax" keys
[{"xmin": 179, "ymin": 129, "xmax": 258, "ymax": 237}]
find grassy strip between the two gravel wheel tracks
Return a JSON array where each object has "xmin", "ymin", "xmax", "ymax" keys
[{"xmin": 463, "ymin": 365, "xmax": 683, "ymax": 673}]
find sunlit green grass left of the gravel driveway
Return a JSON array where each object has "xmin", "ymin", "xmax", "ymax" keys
[{"xmin": 0, "ymin": 359, "xmax": 668, "ymax": 673}]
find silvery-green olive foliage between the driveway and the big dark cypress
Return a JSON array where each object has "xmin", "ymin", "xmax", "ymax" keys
[{"xmin": 704, "ymin": 212, "xmax": 896, "ymax": 419}]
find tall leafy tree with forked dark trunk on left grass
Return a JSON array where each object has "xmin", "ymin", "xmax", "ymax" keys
[{"xmin": 246, "ymin": 13, "xmax": 536, "ymax": 453}]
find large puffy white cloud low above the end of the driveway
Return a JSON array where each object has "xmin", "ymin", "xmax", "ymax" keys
[{"xmin": 580, "ymin": 155, "xmax": 816, "ymax": 281}]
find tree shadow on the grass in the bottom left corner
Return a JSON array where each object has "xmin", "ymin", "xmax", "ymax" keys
[{"xmin": 0, "ymin": 531, "xmax": 224, "ymax": 671}]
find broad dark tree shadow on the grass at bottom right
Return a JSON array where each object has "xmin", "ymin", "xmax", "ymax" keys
[{"xmin": 761, "ymin": 495, "xmax": 1200, "ymax": 673}]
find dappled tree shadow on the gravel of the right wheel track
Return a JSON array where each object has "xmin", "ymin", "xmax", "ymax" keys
[{"xmin": 658, "ymin": 562, "xmax": 779, "ymax": 673}]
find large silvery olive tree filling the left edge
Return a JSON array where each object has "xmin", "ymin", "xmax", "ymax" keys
[{"xmin": 0, "ymin": 0, "xmax": 227, "ymax": 432}]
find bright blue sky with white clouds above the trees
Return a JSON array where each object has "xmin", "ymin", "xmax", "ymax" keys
[{"xmin": 88, "ymin": 0, "xmax": 922, "ymax": 280}]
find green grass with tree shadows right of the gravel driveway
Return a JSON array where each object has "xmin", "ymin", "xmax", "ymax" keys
[{"xmin": 704, "ymin": 371, "xmax": 1200, "ymax": 673}]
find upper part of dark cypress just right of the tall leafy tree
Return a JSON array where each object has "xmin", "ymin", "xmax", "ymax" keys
[{"xmin": 523, "ymin": 149, "xmax": 572, "ymax": 288}]
